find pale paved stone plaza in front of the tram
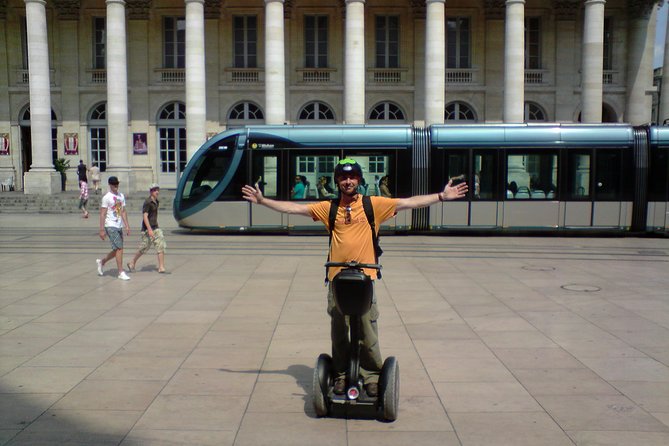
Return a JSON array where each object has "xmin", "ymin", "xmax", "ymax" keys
[{"xmin": 0, "ymin": 214, "xmax": 669, "ymax": 446}]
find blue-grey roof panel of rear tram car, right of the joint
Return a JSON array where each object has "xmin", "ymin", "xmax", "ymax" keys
[{"xmin": 430, "ymin": 123, "xmax": 634, "ymax": 148}]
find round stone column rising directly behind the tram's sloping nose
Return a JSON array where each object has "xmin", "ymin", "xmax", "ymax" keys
[{"xmin": 186, "ymin": 0, "xmax": 207, "ymax": 160}]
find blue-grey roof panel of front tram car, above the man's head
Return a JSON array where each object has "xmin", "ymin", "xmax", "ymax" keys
[{"xmin": 246, "ymin": 125, "xmax": 413, "ymax": 149}]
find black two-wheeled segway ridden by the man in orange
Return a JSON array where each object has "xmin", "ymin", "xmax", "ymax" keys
[{"xmin": 313, "ymin": 262, "xmax": 400, "ymax": 421}]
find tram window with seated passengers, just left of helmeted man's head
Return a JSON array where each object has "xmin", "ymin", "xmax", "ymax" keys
[{"xmin": 289, "ymin": 155, "xmax": 339, "ymax": 200}]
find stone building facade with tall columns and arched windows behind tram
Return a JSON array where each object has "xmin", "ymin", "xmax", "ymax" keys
[{"xmin": 0, "ymin": 0, "xmax": 666, "ymax": 194}]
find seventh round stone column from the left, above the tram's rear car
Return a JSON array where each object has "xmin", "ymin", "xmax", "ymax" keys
[{"xmin": 504, "ymin": 0, "xmax": 525, "ymax": 122}]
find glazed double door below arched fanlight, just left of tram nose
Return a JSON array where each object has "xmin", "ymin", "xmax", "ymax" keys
[{"xmin": 158, "ymin": 127, "xmax": 188, "ymax": 189}]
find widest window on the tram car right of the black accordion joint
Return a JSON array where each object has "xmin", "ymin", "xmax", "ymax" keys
[{"xmin": 506, "ymin": 153, "xmax": 558, "ymax": 199}]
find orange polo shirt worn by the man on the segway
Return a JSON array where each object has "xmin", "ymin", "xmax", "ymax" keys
[{"xmin": 309, "ymin": 194, "xmax": 398, "ymax": 280}]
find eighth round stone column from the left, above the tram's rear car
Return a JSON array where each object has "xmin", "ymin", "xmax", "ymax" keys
[{"xmin": 581, "ymin": 0, "xmax": 606, "ymax": 122}]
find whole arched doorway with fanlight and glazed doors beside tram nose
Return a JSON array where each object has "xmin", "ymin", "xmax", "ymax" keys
[{"xmin": 158, "ymin": 101, "xmax": 188, "ymax": 188}]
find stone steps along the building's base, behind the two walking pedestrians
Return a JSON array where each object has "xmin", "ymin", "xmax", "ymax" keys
[{"xmin": 0, "ymin": 190, "xmax": 175, "ymax": 214}]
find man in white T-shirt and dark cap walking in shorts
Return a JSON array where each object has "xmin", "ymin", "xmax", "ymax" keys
[{"xmin": 95, "ymin": 177, "xmax": 130, "ymax": 280}]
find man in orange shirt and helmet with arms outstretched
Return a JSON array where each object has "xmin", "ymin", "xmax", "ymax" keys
[{"xmin": 242, "ymin": 159, "xmax": 467, "ymax": 396}]
